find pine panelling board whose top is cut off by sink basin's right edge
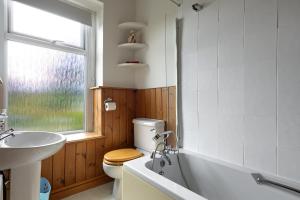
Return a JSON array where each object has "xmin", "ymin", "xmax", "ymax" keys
[{"xmin": 52, "ymin": 147, "xmax": 65, "ymax": 189}]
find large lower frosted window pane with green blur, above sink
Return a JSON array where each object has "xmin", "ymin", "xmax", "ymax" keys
[{"xmin": 8, "ymin": 41, "xmax": 85, "ymax": 132}]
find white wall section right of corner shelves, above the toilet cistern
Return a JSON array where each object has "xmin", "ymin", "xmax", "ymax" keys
[{"xmin": 135, "ymin": 0, "xmax": 177, "ymax": 89}]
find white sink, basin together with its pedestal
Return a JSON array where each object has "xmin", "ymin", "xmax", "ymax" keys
[{"xmin": 0, "ymin": 132, "xmax": 66, "ymax": 200}]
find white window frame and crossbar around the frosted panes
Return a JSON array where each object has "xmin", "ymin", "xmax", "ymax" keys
[{"xmin": 0, "ymin": 0, "xmax": 103, "ymax": 134}]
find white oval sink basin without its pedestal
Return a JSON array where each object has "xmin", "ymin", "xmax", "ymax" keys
[{"xmin": 0, "ymin": 132, "xmax": 66, "ymax": 170}]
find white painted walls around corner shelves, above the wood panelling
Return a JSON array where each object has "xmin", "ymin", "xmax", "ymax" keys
[{"xmin": 96, "ymin": 0, "xmax": 177, "ymax": 88}]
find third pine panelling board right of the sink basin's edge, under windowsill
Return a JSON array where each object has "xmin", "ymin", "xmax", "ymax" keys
[{"xmin": 86, "ymin": 140, "xmax": 96, "ymax": 179}]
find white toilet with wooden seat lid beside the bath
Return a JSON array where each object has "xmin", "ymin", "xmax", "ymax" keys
[{"xmin": 103, "ymin": 118, "xmax": 165, "ymax": 200}]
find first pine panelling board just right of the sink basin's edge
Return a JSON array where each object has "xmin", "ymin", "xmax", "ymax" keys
[{"xmin": 65, "ymin": 143, "xmax": 76, "ymax": 186}]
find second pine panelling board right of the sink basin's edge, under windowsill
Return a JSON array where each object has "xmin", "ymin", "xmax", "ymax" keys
[{"xmin": 76, "ymin": 142, "xmax": 86, "ymax": 183}]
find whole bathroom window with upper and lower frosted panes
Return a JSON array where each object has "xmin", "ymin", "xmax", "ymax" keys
[{"xmin": 7, "ymin": 0, "xmax": 91, "ymax": 132}]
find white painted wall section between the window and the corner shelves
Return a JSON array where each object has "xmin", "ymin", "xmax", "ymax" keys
[{"xmin": 96, "ymin": 0, "xmax": 136, "ymax": 88}]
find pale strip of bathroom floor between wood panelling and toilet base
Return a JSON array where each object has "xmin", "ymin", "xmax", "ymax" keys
[{"xmin": 63, "ymin": 182, "xmax": 114, "ymax": 200}]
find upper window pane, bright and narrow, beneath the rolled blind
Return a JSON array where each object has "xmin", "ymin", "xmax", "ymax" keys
[{"xmin": 10, "ymin": 1, "xmax": 84, "ymax": 48}]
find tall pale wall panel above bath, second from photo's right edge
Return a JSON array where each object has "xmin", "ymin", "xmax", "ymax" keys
[{"xmin": 244, "ymin": 0, "xmax": 277, "ymax": 173}]
